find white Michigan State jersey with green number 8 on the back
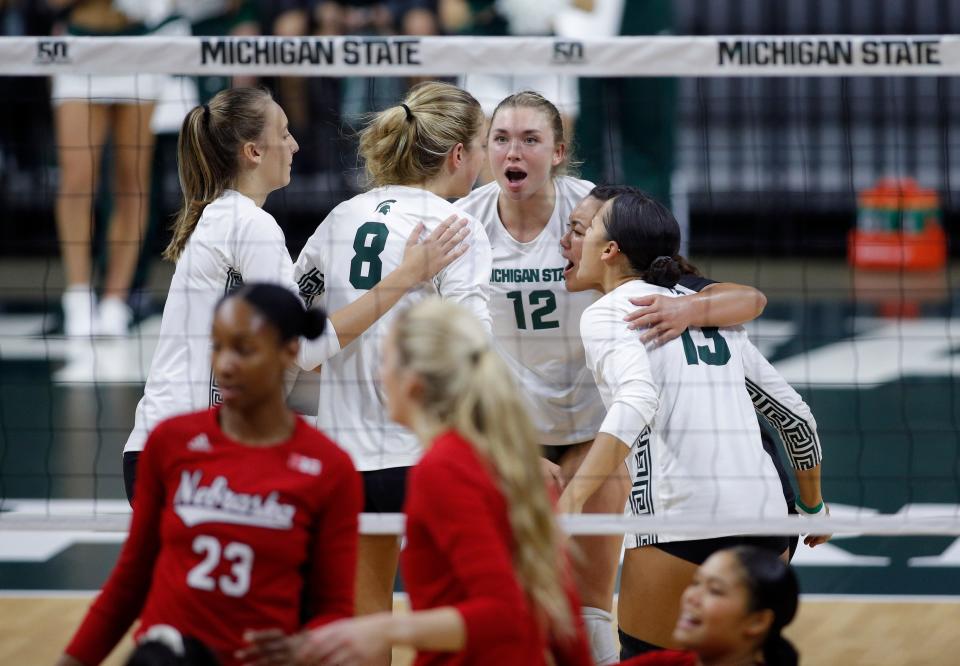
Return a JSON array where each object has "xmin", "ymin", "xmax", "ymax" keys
[{"xmin": 294, "ymin": 185, "xmax": 490, "ymax": 471}]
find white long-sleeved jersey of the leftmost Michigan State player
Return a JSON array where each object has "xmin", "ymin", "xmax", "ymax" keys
[{"xmin": 123, "ymin": 190, "xmax": 336, "ymax": 452}]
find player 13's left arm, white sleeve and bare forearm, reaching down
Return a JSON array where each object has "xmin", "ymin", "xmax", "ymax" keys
[{"xmin": 558, "ymin": 306, "xmax": 659, "ymax": 513}]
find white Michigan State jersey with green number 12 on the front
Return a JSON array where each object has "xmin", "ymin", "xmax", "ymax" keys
[{"xmin": 457, "ymin": 176, "xmax": 604, "ymax": 446}]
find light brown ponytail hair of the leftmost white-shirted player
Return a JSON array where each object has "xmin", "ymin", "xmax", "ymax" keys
[{"xmin": 163, "ymin": 88, "xmax": 273, "ymax": 261}]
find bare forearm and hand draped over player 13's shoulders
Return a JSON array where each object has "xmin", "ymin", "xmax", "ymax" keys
[{"xmin": 626, "ymin": 276, "xmax": 767, "ymax": 344}]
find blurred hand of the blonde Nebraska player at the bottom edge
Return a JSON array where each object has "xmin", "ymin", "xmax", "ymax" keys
[{"xmin": 294, "ymin": 613, "xmax": 392, "ymax": 666}]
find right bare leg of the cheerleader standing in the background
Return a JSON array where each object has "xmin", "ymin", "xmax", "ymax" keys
[{"xmin": 104, "ymin": 104, "xmax": 154, "ymax": 300}]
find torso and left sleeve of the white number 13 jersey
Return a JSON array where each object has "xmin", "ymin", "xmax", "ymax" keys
[{"xmin": 580, "ymin": 280, "xmax": 787, "ymax": 548}]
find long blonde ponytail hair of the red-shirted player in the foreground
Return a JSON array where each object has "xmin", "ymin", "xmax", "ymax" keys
[{"xmin": 394, "ymin": 298, "xmax": 573, "ymax": 636}]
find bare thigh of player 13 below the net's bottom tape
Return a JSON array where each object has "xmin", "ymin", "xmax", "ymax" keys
[{"xmin": 617, "ymin": 546, "xmax": 697, "ymax": 647}]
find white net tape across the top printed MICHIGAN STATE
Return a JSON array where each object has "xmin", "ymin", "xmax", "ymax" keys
[{"xmin": 0, "ymin": 35, "xmax": 960, "ymax": 77}]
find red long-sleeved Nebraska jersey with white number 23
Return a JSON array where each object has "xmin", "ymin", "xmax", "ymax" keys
[{"xmin": 67, "ymin": 409, "xmax": 363, "ymax": 665}]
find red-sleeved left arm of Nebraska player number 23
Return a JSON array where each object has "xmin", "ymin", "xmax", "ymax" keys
[{"xmin": 58, "ymin": 424, "xmax": 165, "ymax": 666}]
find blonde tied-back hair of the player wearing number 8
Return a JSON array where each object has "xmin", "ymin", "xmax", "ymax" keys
[{"xmin": 360, "ymin": 81, "xmax": 483, "ymax": 187}]
